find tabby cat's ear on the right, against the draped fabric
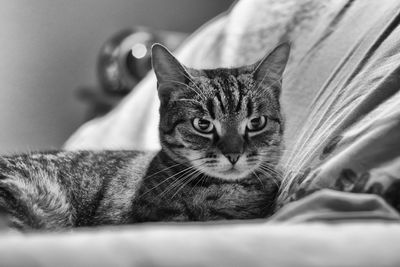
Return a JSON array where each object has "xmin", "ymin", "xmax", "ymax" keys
[{"xmin": 254, "ymin": 43, "xmax": 290, "ymax": 84}]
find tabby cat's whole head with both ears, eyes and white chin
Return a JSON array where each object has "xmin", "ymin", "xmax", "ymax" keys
[{"xmin": 153, "ymin": 45, "xmax": 289, "ymax": 180}]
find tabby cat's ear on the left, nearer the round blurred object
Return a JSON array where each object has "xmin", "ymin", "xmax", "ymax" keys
[{"xmin": 151, "ymin": 44, "xmax": 189, "ymax": 84}]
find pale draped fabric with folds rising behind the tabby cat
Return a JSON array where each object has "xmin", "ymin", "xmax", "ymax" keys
[{"xmin": 66, "ymin": 0, "xmax": 400, "ymax": 219}]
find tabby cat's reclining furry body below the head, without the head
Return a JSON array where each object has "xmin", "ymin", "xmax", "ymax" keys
[{"xmin": 0, "ymin": 151, "xmax": 277, "ymax": 230}]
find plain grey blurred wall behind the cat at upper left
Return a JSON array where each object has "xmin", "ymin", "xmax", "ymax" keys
[{"xmin": 0, "ymin": 0, "xmax": 233, "ymax": 153}]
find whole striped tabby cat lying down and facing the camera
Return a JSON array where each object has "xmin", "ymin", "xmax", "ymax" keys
[{"xmin": 0, "ymin": 44, "xmax": 290, "ymax": 230}]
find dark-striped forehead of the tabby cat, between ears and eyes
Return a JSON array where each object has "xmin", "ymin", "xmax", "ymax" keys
[{"xmin": 173, "ymin": 68, "xmax": 279, "ymax": 123}]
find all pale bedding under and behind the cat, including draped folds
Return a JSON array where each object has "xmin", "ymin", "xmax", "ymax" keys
[{"xmin": 0, "ymin": 0, "xmax": 400, "ymax": 266}]
